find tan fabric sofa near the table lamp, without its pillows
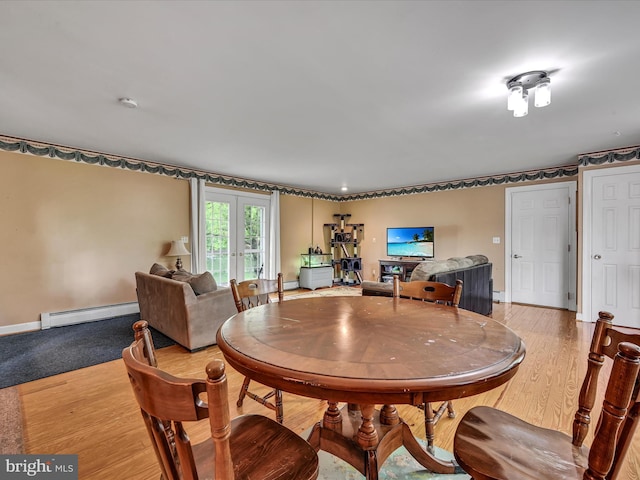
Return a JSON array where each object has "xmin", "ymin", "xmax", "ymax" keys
[{"xmin": 136, "ymin": 272, "xmax": 237, "ymax": 351}]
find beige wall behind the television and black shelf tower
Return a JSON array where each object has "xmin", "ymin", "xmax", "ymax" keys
[{"xmin": 280, "ymin": 186, "xmax": 505, "ymax": 290}]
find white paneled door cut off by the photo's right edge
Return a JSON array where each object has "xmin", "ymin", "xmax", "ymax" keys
[{"xmin": 583, "ymin": 166, "xmax": 640, "ymax": 328}]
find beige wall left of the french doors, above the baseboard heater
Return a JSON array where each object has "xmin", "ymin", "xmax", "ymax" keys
[{"xmin": 0, "ymin": 152, "xmax": 189, "ymax": 326}]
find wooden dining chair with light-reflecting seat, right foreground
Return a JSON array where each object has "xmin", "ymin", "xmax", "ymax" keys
[{"xmin": 453, "ymin": 312, "xmax": 640, "ymax": 480}]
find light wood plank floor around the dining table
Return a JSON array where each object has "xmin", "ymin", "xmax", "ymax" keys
[{"xmin": 19, "ymin": 304, "xmax": 640, "ymax": 480}]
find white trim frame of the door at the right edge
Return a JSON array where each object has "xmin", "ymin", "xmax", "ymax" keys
[{"xmin": 576, "ymin": 165, "xmax": 640, "ymax": 322}]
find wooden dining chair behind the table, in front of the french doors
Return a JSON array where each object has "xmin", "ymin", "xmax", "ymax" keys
[{"xmin": 230, "ymin": 273, "xmax": 284, "ymax": 423}]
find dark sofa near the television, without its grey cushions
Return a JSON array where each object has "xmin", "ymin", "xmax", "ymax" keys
[{"xmin": 362, "ymin": 263, "xmax": 493, "ymax": 315}]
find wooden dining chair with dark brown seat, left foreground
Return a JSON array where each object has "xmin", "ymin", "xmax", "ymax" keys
[{"xmin": 122, "ymin": 321, "xmax": 318, "ymax": 480}]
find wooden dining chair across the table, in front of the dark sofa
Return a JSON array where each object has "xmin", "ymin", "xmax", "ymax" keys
[{"xmin": 393, "ymin": 275, "xmax": 462, "ymax": 452}]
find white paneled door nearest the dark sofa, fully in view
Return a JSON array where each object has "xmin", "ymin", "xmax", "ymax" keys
[{"xmin": 505, "ymin": 182, "xmax": 576, "ymax": 309}]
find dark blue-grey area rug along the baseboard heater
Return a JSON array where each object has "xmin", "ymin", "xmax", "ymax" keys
[{"xmin": 0, "ymin": 313, "xmax": 175, "ymax": 388}]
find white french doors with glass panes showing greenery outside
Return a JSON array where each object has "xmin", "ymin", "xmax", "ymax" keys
[{"xmin": 205, "ymin": 188, "xmax": 270, "ymax": 285}]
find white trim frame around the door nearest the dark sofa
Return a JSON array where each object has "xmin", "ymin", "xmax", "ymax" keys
[{"xmin": 504, "ymin": 181, "xmax": 578, "ymax": 311}]
